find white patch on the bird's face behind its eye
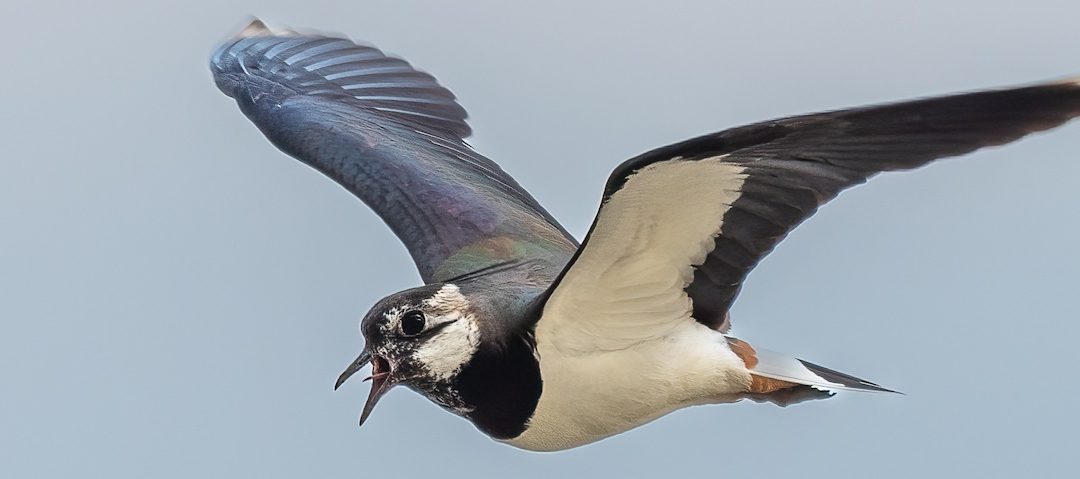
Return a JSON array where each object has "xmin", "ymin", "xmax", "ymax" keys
[{"xmin": 411, "ymin": 285, "xmax": 480, "ymax": 380}]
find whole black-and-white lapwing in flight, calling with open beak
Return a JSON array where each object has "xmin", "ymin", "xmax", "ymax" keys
[{"xmin": 211, "ymin": 20, "xmax": 1080, "ymax": 451}]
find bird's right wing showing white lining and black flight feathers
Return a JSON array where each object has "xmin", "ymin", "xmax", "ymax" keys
[{"xmin": 537, "ymin": 76, "xmax": 1080, "ymax": 351}]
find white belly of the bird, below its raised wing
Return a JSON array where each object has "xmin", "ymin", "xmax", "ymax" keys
[{"xmin": 505, "ymin": 321, "xmax": 751, "ymax": 451}]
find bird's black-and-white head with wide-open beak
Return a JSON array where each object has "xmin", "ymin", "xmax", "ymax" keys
[{"xmin": 335, "ymin": 284, "xmax": 480, "ymax": 425}]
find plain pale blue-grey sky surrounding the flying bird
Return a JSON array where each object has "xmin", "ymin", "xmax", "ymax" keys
[{"xmin": 0, "ymin": 0, "xmax": 1080, "ymax": 479}]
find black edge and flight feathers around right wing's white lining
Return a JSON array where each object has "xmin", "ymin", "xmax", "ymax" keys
[{"xmin": 534, "ymin": 78, "xmax": 1080, "ymax": 329}]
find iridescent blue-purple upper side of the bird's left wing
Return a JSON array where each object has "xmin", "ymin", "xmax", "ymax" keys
[{"xmin": 211, "ymin": 20, "xmax": 577, "ymax": 283}]
